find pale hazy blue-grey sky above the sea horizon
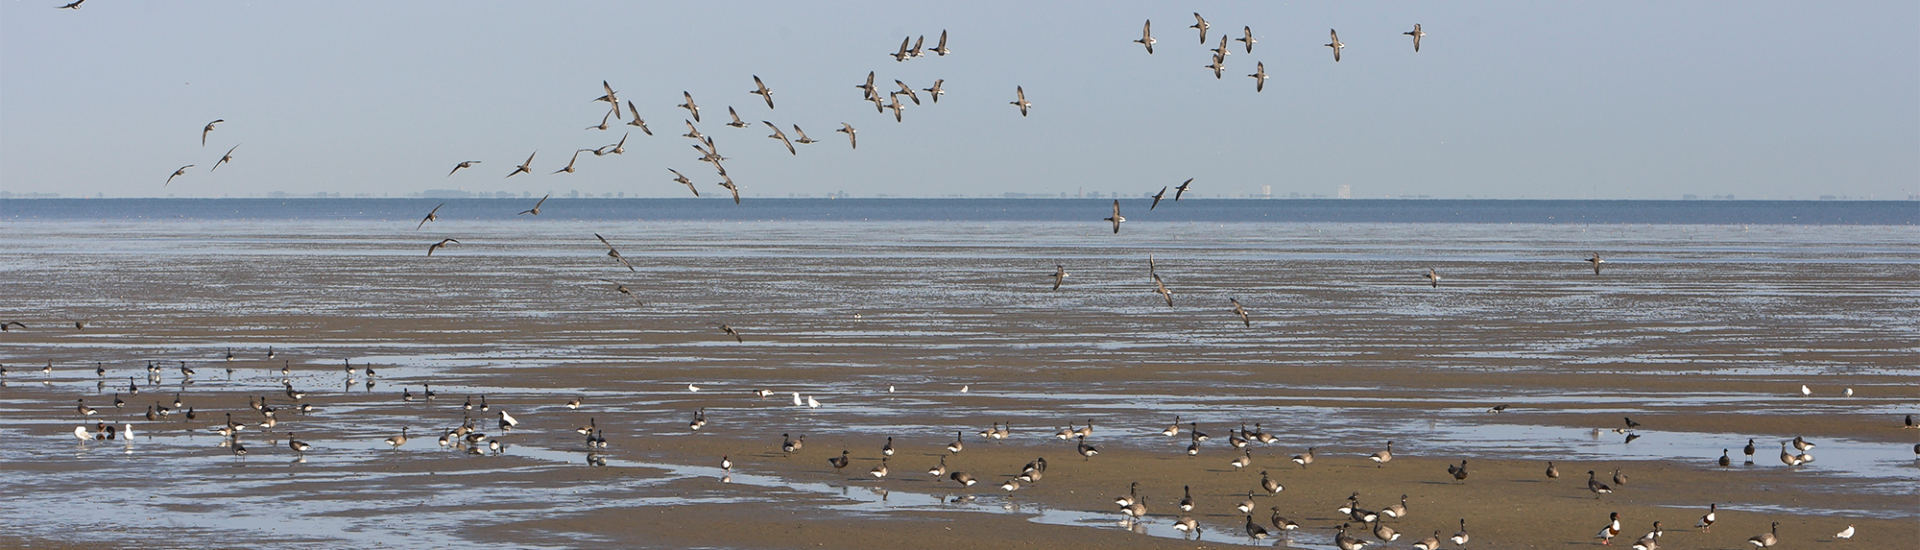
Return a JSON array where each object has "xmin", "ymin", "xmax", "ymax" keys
[{"xmin": 0, "ymin": 0, "xmax": 1920, "ymax": 198}]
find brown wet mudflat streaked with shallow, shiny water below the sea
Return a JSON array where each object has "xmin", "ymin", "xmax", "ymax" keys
[{"xmin": 0, "ymin": 223, "xmax": 1920, "ymax": 548}]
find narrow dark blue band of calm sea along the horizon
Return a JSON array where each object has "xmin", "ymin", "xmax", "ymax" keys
[{"xmin": 0, "ymin": 198, "xmax": 1920, "ymax": 225}]
